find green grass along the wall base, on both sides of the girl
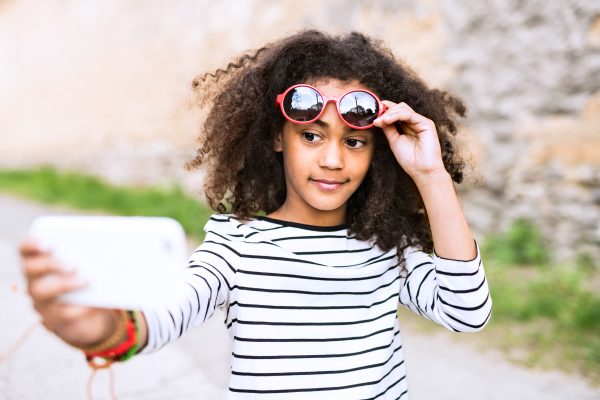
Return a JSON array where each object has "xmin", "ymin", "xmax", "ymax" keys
[{"xmin": 0, "ymin": 168, "xmax": 600, "ymax": 380}]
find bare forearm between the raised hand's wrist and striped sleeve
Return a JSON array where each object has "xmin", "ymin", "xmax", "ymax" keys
[{"xmin": 415, "ymin": 170, "xmax": 477, "ymax": 261}]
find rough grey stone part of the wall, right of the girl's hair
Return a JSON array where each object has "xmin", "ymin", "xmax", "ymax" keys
[{"xmin": 440, "ymin": 0, "xmax": 600, "ymax": 258}]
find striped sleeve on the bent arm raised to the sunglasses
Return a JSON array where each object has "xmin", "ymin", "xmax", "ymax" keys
[{"xmin": 400, "ymin": 243, "xmax": 492, "ymax": 332}]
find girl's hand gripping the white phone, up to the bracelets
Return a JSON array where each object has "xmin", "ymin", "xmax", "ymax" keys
[{"xmin": 20, "ymin": 239, "xmax": 118, "ymax": 345}]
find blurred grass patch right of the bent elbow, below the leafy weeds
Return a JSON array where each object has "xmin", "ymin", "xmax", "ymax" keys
[{"xmin": 483, "ymin": 260, "xmax": 600, "ymax": 379}]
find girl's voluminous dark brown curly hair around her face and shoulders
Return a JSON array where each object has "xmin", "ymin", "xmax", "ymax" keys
[{"xmin": 187, "ymin": 30, "xmax": 466, "ymax": 268}]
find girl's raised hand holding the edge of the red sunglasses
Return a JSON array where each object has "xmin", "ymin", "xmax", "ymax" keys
[{"xmin": 375, "ymin": 100, "xmax": 446, "ymax": 184}]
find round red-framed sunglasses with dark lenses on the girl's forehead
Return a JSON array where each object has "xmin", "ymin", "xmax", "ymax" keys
[{"xmin": 275, "ymin": 84, "xmax": 386, "ymax": 129}]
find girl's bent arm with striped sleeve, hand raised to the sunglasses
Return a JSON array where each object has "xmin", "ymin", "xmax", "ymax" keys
[{"xmin": 375, "ymin": 101, "xmax": 492, "ymax": 332}]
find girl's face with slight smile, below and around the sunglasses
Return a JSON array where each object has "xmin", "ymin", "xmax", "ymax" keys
[{"xmin": 275, "ymin": 79, "xmax": 374, "ymax": 221}]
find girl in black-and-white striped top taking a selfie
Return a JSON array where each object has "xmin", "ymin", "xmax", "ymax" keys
[{"xmin": 21, "ymin": 30, "xmax": 492, "ymax": 399}]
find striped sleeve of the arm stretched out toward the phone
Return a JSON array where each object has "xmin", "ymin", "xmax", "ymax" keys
[{"xmin": 141, "ymin": 217, "xmax": 242, "ymax": 354}]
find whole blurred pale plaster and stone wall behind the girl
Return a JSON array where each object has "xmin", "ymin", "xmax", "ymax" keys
[{"xmin": 0, "ymin": 0, "xmax": 600, "ymax": 258}]
